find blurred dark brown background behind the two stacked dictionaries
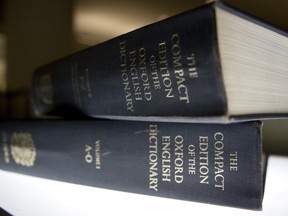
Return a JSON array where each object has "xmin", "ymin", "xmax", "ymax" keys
[{"xmin": 0, "ymin": 0, "xmax": 288, "ymax": 155}]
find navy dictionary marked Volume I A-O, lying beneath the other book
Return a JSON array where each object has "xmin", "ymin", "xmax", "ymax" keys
[{"xmin": 0, "ymin": 120, "xmax": 265, "ymax": 210}]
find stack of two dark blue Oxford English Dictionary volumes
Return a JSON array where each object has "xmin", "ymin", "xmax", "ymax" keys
[{"xmin": 0, "ymin": 2, "xmax": 288, "ymax": 210}]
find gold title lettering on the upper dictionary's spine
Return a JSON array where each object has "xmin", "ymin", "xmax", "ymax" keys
[{"xmin": 118, "ymin": 33, "xmax": 198, "ymax": 113}]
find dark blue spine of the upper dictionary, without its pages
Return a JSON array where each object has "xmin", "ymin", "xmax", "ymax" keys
[{"xmin": 32, "ymin": 5, "xmax": 227, "ymax": 117}]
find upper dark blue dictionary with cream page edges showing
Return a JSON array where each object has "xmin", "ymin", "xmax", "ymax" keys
[{"xmin": 32, "ymin": 2, "xmax": 288, "ymax": 122}]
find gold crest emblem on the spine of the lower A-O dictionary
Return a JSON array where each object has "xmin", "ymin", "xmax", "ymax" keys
[{"xmin": 11, "ymin": 133, "xmax": 36, "ymax": 167}]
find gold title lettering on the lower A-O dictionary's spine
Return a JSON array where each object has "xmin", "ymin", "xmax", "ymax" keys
[{"xmin": 148, "ymin": 125, "xmax": 228, "ymax": 191}]
